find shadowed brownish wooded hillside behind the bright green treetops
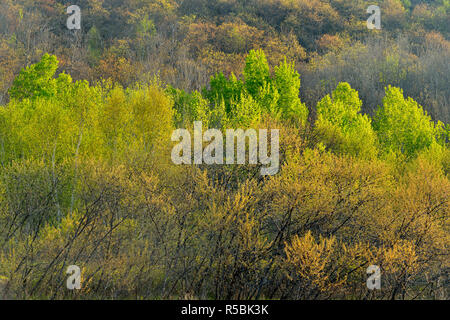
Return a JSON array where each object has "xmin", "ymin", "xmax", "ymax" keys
[{"xmin": 0, "ymin": 0, "xmax": 450, "ymax": 122}]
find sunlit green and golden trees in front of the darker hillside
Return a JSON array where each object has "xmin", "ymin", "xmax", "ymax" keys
[{"xmin": 0, "ymin": 50, "xmax": 450, "ymax": 299}]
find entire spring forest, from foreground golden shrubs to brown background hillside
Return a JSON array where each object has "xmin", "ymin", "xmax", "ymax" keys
[{"xmin": 0, "ymin": 0, "xmax": 450, "ymax": 300}]
